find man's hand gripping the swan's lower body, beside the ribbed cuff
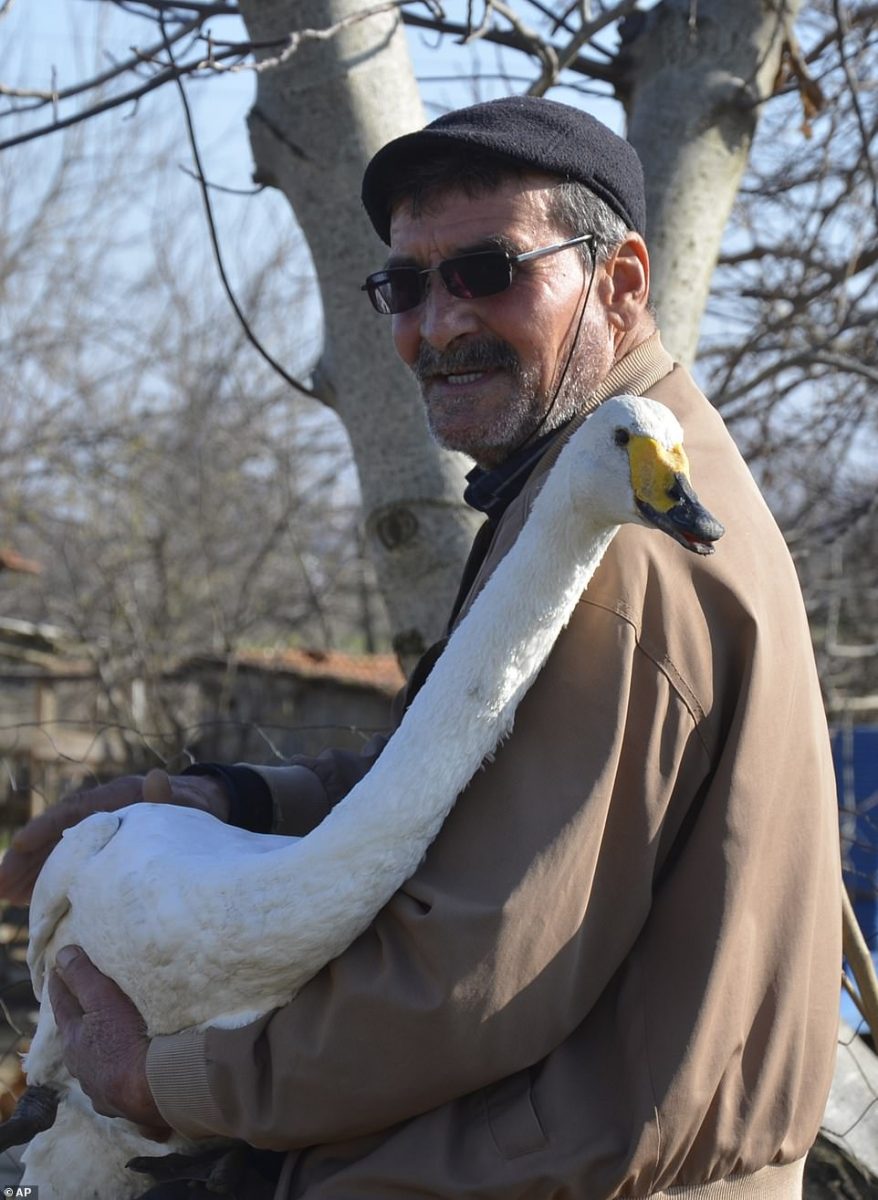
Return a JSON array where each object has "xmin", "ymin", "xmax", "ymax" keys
[{"xmin": 49, "ymin": 946, "xmax": 170, "ymax": 1140}]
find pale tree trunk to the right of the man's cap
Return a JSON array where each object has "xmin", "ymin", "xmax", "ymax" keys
[{"xmin": 623, "ymin": 0, "xmax": 799, "ymax": 364}]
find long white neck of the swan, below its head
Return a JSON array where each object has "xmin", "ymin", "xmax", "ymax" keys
[{"xmin": 202, "ymin": 448, "xmax": 617, "ymax": 990}]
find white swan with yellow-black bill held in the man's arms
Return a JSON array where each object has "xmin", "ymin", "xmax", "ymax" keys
[{"xmin": 10, "ymin": 396, "xmax": 723, "ymax": 1200}]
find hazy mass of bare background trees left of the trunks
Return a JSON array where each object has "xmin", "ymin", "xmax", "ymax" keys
[{"xmin": 0, "ymin": 121, "xmax": 386, "ymax": 733}]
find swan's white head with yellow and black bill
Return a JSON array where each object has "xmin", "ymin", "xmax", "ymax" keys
[{"xmin": 571, "ymin": 396, "xmax": 726, "ymax": 554}]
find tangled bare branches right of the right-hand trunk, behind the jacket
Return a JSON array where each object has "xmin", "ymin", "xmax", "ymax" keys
[{"xmin": 699, "ymin": 2, "xmax": 878, "ymax": 718}]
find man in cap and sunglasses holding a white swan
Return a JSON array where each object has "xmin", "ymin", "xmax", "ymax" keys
[{"xmin": 0, "ymin": 98, "xmax": 841, "ymax": 1200}]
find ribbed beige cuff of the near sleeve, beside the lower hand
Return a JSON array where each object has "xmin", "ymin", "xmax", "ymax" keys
[{"xmin": 146, "ymin": 1030, "xmax": 224, "ymax": 1138}]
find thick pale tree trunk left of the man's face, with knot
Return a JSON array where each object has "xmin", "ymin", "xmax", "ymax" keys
[{"xmin": 240, "ymin": 0, "xmax": 474, "ymax": 662}]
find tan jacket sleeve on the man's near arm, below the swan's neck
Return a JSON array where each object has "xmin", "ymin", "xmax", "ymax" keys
[{"xmin": 142, "ymin": 600, "xmax": 708, "ymax": 1150}]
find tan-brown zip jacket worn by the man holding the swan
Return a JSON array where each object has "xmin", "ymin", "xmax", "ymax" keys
[{"xmin": 149, "ymin": 337, "xmax": 841, "ymax": 1200}]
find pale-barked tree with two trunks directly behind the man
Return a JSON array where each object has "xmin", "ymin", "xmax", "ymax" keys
[{"xmin": 7, "ymin": 0, "xmax": 870, "ymax": 650}]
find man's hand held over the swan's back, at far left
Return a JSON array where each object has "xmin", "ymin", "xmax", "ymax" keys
[{"xmin": 0, "ymin": 770, "xmax": 229, "ymax": 904}]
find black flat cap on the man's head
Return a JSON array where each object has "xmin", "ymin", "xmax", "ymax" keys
[{"xmin": 362, "ymin": 96, "xmax": 647, "ymax": 245}]
